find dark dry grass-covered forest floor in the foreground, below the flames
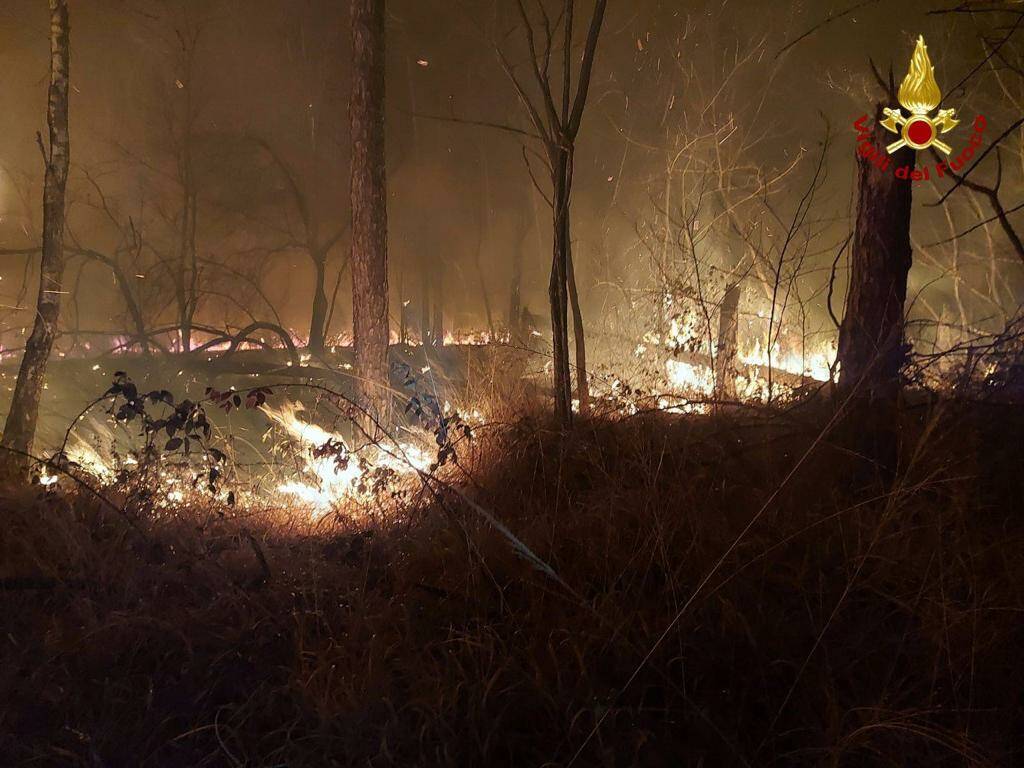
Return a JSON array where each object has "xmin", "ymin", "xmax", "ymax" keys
[{"xmin": 0, "ymin": 399, "xmax": 1024, "ymax": 768}]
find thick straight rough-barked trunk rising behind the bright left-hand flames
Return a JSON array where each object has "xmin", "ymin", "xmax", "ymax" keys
[{"xmin": 349, "ymin": 0, "xmax": 389, "ymax": 411}]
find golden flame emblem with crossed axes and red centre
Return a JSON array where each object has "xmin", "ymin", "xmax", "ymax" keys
[{"xmin": 882, "ymin": 36, "xmax": 959, "ymax": 155}]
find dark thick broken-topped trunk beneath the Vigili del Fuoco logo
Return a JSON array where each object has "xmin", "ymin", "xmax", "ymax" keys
[{"xmin": 839, "ymin": 105, "xmax": 915, "ymax": 400}]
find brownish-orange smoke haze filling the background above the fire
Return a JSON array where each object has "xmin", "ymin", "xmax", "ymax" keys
[{"xmin": 0, "ymin": 0, "xmax": 1006, "ymax": 347}]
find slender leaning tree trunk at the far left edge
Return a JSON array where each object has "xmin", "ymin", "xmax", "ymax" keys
[{"xmin": 0, "ymin": 0, "xmax": 71, "ymax": 475}]
